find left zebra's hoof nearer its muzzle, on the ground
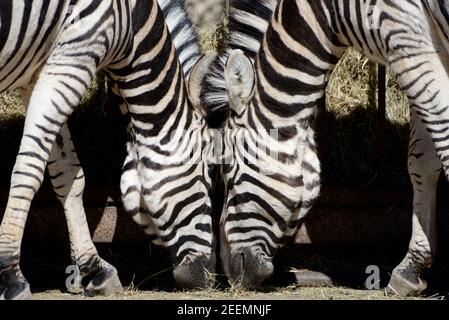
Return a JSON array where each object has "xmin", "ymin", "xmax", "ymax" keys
[{"xmin": 85, "ymin": 264, "xmax": 123, "ymax": 296}]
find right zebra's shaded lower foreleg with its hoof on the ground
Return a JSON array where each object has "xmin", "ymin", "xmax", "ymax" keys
[{"xmin": 387, "ymin": 110, "xmax": 442, "ymax": 296}]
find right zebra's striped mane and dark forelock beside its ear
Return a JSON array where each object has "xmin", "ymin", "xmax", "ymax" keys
[{"xmin": 201, "ymin": 0, "xmax": 278, "ymax": 127}]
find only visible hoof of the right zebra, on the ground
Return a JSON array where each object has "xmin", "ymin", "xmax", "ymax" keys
[{"xmin": 385, "ymin": 271, "xmax": 427, "ymax": 297}]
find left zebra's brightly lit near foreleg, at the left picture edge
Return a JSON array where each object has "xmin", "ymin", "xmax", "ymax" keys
[{"xmin": 0, "ymin": 63, "xmax": 96, "ymax": 299}]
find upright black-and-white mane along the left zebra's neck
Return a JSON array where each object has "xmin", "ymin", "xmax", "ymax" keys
[{"xmin": 158, "ymin": 0, "xmax": 202, "ymax": 78}]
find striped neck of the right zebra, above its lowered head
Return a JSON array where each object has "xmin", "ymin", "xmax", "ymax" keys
[{"xmin": 238, "ymin": 0, "xmax": 347, "ymax": 131}]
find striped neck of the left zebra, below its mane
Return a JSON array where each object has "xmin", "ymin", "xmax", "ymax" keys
[{"xmin": 121, "ymin": 1, "xmax": 199, "ymax": 139}]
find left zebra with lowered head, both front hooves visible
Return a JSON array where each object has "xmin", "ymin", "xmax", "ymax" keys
[{"xmin": 0, "ymin": 0, "xmax": 214, "ymax": 299}]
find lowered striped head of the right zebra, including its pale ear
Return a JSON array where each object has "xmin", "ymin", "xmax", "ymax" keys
[{"xmin": 220, "ymin": 50, "xmax": 316, "ymax": 288}]
